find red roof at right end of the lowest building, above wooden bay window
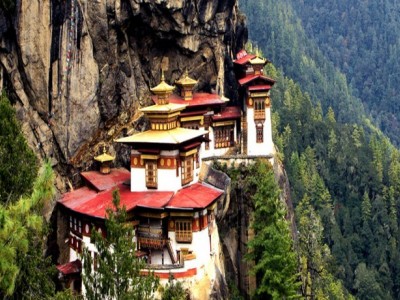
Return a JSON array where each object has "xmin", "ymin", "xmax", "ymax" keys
[{"xmin": 167, "ymin": 183, "xmax": 224, "ymax": 209}]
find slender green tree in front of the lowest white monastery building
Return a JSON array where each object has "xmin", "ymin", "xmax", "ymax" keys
[{"xmin": 83, "ymin": 190, "xmax": 159, "ymax": 300}]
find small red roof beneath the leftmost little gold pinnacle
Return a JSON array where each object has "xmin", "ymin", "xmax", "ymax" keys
[{"xmin": 81, "ymin": 168, "xmax": 131, "ymax": 191}]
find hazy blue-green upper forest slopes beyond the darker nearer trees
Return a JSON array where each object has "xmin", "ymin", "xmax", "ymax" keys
[{"xmin": 240, "ymin": 0, "xmax": 400, "ymax": 145}]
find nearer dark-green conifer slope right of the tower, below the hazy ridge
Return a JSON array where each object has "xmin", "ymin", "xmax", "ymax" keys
[{"xmin": 260, "ymin": 61, "xmax": 400, "ymax": 299}]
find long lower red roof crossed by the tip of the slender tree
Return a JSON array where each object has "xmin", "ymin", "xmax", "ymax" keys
[{"xmin": 58, "ymin": 184, "xmax": 174, "ymax": 219}]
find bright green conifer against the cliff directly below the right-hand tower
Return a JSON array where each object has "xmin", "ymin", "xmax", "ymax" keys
[{"xmin": 246, "ymin": 161, "xmax": 299, "ymax": 299}]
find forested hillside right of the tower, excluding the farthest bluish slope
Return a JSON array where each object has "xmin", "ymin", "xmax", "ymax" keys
[{"xmin": 241, "ymin": 1, "xmax": 400, "ymax": 299}]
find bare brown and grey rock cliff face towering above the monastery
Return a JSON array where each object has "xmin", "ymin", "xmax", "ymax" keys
[{"xmin": 0, "ymin": 0, "xmax": 247, "ymax": 191}]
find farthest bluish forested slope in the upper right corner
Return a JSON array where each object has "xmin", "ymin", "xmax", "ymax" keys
[{"xmin": 289, "ymin": 0, "xmax": 400, "ymax": 145}]
